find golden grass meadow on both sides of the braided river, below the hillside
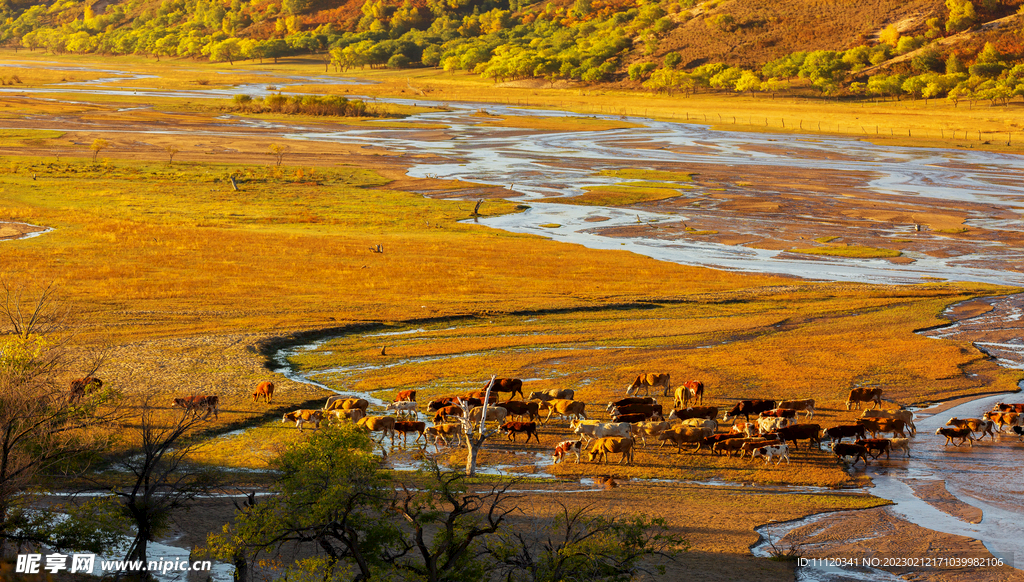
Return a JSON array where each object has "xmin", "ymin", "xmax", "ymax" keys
[{"xmin": 0, "ymin": 50, "xmax": 1024, "ymax": 581}]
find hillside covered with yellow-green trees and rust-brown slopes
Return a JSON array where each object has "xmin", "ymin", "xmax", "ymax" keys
[{"xmin": 0, "ymin": 0, "xmax": 1024, "ymax": 100}]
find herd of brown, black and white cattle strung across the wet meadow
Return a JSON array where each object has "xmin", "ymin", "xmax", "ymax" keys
[{"xmin": 108, "ymin": 374, "xmax": 1024, "ymax": 465}]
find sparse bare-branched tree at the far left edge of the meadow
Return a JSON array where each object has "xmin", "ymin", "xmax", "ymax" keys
[{"xmin": 0, "ymin": 281, "xmax": 121, "ymax": 549}]
